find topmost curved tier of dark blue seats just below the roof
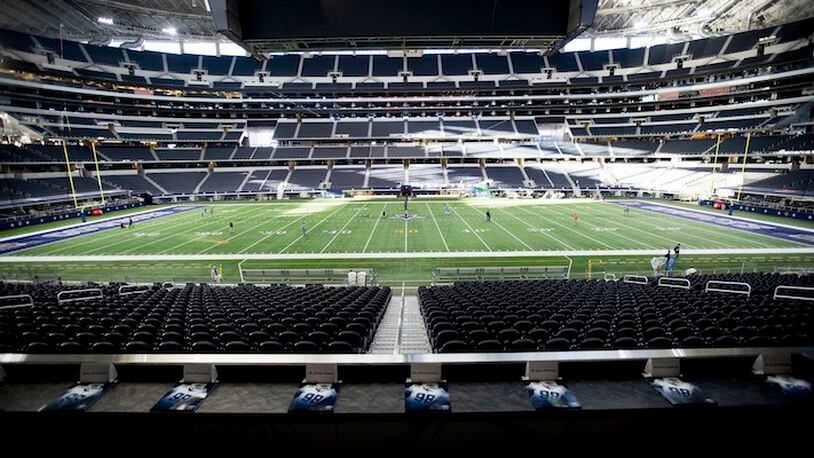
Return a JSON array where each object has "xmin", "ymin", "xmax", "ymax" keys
[{"xmin": 0, "ymin": 16, "xmax": 811, "ymax": 77}]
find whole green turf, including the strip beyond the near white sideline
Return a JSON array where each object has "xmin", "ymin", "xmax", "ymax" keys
[{"xmin": 0, "ymin": 199, "xmax": 814, "ymax": 284}]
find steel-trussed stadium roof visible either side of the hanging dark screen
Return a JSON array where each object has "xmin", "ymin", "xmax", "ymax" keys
[{"xmin": 0, "ymin": 0, "xmax": 814, "ymax": 43}]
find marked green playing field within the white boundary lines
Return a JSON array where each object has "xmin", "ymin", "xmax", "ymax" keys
[{"xmin": 6, "ymin": 199, "xmax": 805, "ymax": 256}]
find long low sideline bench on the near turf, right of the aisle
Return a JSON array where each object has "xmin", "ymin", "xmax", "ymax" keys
[{"xmin": 432, "ymin": 265, "xmax": 571, "ymax": 284}]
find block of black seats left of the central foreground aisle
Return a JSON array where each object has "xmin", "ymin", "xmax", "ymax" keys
[{"xmin": 0, "ymin": 284, "xmax": 391, "ymax": 354}]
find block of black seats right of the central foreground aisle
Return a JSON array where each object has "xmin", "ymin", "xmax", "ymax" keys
[{"xmin": 418, "ymin": 274, "xmax": 814, "ymax": 352}]
